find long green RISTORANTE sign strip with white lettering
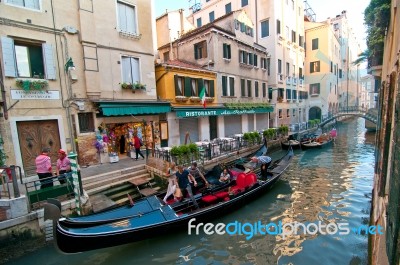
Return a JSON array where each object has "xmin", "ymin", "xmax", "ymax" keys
[{"xmin": 176, "ymin": 108, "xmax": 273, "ymax": 118}]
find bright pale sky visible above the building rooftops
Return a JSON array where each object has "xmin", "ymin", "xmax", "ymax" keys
[{"xmin": 154, "ymin": 0, "xmax": 370, "ymax": 50}]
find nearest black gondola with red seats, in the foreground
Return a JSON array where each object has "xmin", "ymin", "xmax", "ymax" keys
[{"xmin": 45, "ymin": 145, "xmax": 293, "ymax": 253}]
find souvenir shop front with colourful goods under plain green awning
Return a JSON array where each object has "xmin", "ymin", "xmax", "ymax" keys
[{"xmin": 96, "ymin": 102, "xmax": 171, "ymax": 162}]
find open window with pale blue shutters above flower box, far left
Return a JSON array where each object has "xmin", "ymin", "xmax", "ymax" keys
[{"xmin": 1, "ymin": 37, "xmax": 56, "ymax": 79}]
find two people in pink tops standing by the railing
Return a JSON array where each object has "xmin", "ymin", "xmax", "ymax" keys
[{"xmin": 35, "ymin": 147, "xmax": 71, "ymax": 188}]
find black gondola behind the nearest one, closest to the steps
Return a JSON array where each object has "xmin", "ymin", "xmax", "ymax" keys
[{"xmin": 50, "ymin": 138, "xmax": 267, "ymax": 228}]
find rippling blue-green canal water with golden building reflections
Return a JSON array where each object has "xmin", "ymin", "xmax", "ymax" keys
[{"xmin": 10, "ymin": 119, "xmax": 375, "ymax": 265}]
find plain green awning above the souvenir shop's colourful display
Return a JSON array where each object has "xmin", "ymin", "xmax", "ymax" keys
[{"xmin": 99, "ymin": 102, "xmax": 171, "ymax": 116}]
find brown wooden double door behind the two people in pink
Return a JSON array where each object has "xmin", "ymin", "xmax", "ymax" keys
[{"xmin": 17, "ymin": 120, "xmax": 61, "ymax": 176}]
